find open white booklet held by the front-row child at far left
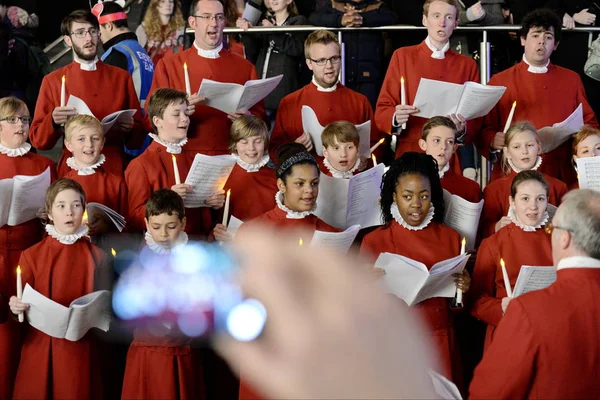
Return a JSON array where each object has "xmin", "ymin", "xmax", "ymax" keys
[{"xmin": 21, "ymin": 284, "xmax": 111, "ymax": 342}]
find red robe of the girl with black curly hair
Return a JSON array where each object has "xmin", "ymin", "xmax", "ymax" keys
[{"xmin": 360, "ymin": 221, "xmax": 462, "ymax": 383}]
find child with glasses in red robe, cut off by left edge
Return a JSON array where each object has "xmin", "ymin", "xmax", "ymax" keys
[{"xmin": 0, "ymin": 97, "xmax": 56, "ymax": 399}]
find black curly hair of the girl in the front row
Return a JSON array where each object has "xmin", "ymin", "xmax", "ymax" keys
[{"xmin": 381, "ymin": 152, "xmax": 446, "ymax": 224}]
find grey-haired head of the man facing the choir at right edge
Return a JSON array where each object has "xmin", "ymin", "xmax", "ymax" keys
[{"xmin": 555, "ymin": 189, "xmax": 600, "ymax": 259}]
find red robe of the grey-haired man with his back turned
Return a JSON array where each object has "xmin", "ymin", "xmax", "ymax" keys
[{"xmin": 470, "ymin": 258, "xmax": 600, "ymax": 399}]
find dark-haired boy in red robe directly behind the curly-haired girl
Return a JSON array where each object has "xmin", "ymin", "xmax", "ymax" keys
[{"xmin": 419, "ymin": 117, "xmax": 481, "ymax": 203}]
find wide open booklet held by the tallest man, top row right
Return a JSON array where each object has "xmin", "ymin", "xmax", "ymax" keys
[{"xmin": 413, "ymin": 78, "xmax": 506, "ymax": 120}]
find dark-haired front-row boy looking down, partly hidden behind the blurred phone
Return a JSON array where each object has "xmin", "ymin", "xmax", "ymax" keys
[{"xmin": 122, "ymin": 189, "xmax": 204, "ymax": 400}]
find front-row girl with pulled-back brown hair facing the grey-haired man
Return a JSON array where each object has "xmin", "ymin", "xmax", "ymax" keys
[{"xmin": 469, "ymin": 170, "xmax": 552, "ymax": 348}]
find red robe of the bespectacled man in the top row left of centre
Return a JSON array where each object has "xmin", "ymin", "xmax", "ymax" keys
[{"xmin": 146, "ymin": 46, "xmax": 268, "ymax": 158}]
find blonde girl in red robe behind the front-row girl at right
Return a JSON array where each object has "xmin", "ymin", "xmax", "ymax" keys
[{"xmin": 479, "ymin": 122, "xmax": 568, "ymax": 239}]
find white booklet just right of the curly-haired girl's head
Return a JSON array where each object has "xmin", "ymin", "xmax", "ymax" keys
[{"xmin": 444, "ymin": 189, "xmax": 483, "ymax": 251}]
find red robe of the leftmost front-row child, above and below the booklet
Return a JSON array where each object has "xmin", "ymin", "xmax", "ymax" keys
[{"xmin": 13, "ymin": 236, "xmax": 108, "ymax": 400}]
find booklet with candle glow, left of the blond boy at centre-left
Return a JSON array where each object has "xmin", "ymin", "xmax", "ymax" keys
[{"xmin": 184, "ymin": 154, "xmax": 236, "ymax": 208}]
